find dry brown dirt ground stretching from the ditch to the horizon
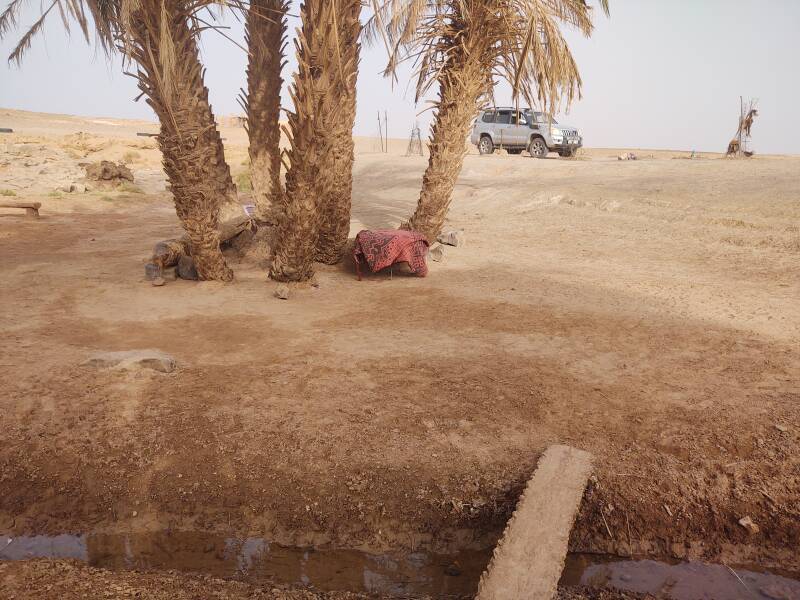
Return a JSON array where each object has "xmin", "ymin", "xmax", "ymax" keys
[{"xmin": 0, "ymin": 110, "xmax": 800, "ymax": 592}]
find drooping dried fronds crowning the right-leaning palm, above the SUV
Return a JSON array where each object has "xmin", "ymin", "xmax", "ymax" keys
[{"xmin": 364, "ymin": 0, "xmax": 608, "ymax": 112}]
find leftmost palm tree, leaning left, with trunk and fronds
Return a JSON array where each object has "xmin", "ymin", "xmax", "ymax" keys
[{"xmin": 0, "ymin": 0, "xmax": 241, "ymax": 281}]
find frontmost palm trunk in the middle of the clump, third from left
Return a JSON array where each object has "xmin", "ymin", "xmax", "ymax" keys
[{"xmin": 270, "ymin": 0, "xmax": 340, "ymax": 281}]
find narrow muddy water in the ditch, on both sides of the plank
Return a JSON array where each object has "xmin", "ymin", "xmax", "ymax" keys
[{"xmin": 0, "ymin": 532, "xmax": 800, "ymax": 600}]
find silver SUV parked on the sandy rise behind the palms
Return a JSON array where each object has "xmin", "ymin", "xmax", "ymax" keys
[{"xmin": 470, "ymin": 107, "xmax": 583, "ymax": 158}]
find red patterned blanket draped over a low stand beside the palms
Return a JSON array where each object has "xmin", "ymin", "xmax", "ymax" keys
[{"xmin": 353, "ymin": 229, "xmax": 428, "ymax": 280}]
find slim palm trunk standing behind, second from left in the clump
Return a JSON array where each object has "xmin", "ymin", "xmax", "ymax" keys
[{"xmin": 242, "ymin": 0, "xmax": 289, "ymax": 221}]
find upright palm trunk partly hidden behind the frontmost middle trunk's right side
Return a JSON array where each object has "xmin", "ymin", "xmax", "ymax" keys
[{"xmin": 317, "ymin": 0, "xmax": 361, "ymax": 265}]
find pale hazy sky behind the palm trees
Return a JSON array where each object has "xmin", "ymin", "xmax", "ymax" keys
[{"xmin": 0, "ymin": 0, "xmax": 800, "ymax": 153}]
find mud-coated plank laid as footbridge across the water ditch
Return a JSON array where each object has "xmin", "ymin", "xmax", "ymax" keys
[{"xmin": 477, "ymin": 446, "xmax": 592, "ymax": 600}]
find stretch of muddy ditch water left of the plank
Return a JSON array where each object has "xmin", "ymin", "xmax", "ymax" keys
[{"xmin": 0, "ymin": 532, "xmax": 491, "ymax": 598}]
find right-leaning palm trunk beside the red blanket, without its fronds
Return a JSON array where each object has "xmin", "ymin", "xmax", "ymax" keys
[{"xmin": 402, "ymin": 17, "xmax": 491, "ymax": 243}]
